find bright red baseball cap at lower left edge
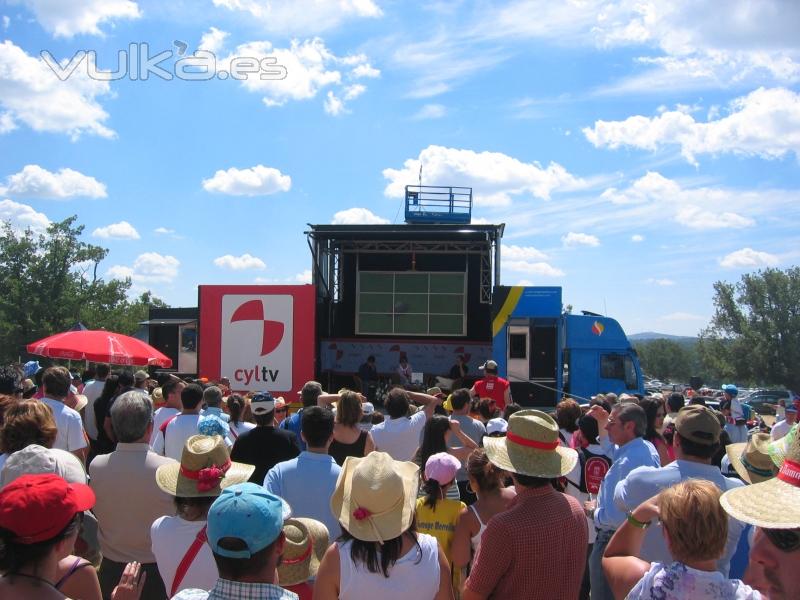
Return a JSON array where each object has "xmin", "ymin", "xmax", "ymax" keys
[{"xmin": 0, "ymin": 473, "xmax": 95, "ymax": 544}]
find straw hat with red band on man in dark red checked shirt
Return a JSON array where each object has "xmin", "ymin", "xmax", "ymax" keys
[{"xmin": 483, "ymin": 410, "xmax": 578, "ymax": 478}]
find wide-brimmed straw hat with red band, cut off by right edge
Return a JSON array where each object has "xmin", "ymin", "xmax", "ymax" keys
[{"xmin": 719, "ymin": 424, "xmax": 800, "ymax": 529}]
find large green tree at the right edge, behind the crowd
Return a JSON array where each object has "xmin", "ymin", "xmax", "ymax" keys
[{"xmin": 699, "ymin": 267, "xmax": 800, "ymax": 390}]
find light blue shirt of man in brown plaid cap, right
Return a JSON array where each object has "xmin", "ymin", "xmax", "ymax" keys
[{"xmin": 614, "ymin": 460, "xmax": 744, "ymax": 577}]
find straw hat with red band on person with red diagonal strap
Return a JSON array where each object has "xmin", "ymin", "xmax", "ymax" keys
[{"xmin": 156, "ymin": 435, "xmax": 256, "ymax": 498}]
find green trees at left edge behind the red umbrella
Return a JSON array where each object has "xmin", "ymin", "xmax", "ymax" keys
[{"xmin": 0, "ymin": 216, "xmax": 169, "ymax": 361}]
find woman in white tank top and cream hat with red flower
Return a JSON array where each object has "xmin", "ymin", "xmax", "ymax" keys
[{"xmin": 314, "ymin": 452, "xmax": 453, "ymax": 600}]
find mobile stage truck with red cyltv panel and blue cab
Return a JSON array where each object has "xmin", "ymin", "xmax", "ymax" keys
[{"xmin": 158, "ymin": 186, "xmax": 643, "ymax": 408}]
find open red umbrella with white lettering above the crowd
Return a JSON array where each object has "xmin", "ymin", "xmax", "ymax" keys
[{"xmin": 28, "ymin": 329, "xmax": 172, "ymax": 367}]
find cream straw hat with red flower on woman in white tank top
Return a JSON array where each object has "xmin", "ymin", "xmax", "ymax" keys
[{"xmin": 331, "ymin": 452, "xmax": 419, "ymax": 543}]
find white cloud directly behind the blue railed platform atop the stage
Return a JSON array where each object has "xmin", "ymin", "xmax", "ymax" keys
[{"xmin": 383, "ymin": 146, "xmax": 583, "ymax": 206}]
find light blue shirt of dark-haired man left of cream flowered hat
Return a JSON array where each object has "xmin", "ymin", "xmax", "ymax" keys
[{"xmin": 264, "ymin": 451, "xmax": 342, "ymax": 541}]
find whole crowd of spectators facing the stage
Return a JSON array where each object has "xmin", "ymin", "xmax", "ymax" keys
[{"xmin": 0, "ymin": 361, "xmax": 800, "ymax": 600}]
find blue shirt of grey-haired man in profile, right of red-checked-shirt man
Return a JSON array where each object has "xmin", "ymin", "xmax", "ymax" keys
[{"xmin": 594, "ymin": 438, "xmax": 661, "ymax": 529}]
